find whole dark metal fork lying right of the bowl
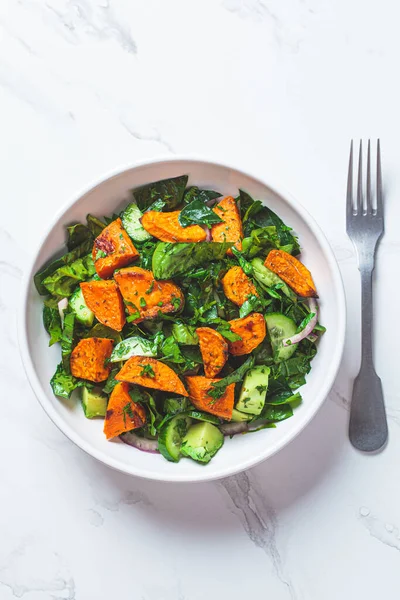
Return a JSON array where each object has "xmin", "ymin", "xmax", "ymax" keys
[{"xmin": 346, "ymin": 140, "xmax": 388, "ymax": 452}]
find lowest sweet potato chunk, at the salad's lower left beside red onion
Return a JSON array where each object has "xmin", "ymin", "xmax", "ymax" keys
[{"xmin": 104, "ymin": 382, "xmax": 146, "ymax": 440}]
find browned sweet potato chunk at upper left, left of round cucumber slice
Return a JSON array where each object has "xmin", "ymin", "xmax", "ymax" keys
[{"xmin": 92, "ymin": 218, "xmax": 139, "ymax": 279}]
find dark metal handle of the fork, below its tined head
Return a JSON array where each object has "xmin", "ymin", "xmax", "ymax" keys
[{"xmin": 349, "ymin": 257, "xmax": 388, "ymax": 452}]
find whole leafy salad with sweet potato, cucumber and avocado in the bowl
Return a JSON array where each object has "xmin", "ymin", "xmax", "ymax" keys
[{"xmin": 34, "ymin": 175, "xmax": 325, "ymax": 464}]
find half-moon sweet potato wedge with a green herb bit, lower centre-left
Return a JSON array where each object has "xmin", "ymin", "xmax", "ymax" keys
[{"xmin": 115, "ymin": 356, "xmax": 188, "ymax": 396}]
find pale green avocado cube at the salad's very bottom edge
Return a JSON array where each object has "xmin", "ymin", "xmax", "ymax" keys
[{"xmin": 181, "ymin": 422, "xmax": 224, "ymax": 463}]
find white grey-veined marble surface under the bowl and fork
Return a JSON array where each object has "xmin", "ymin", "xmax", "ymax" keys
[{"xmin": 0, "ymin": 0, "xmax": 400, "ymax": 600}]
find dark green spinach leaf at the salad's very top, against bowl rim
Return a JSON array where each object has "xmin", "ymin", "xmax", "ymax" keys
[{"xmin": 133, "ymin": 175, "xmax": 188, "ymax": 211}]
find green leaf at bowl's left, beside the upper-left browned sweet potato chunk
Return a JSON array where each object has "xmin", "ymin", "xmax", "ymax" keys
[{"xmin": 43, "ymin": 254, "xmax": 96, "ymax": 298}]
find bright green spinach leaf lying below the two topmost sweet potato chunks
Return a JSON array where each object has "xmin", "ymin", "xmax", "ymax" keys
[{"xmin": 152, "ymin": 242, "xmax": 232, "ymax": 279}]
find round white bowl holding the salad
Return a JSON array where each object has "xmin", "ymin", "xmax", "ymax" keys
[{"xmin": 18, "ymin": 158, "xmax": 345, "ymax": 481}]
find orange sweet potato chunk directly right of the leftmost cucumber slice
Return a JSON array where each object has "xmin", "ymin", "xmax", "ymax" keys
[{"xmin": 81, "ymin": 280, "xmax": 125, "ymax": 331}]
